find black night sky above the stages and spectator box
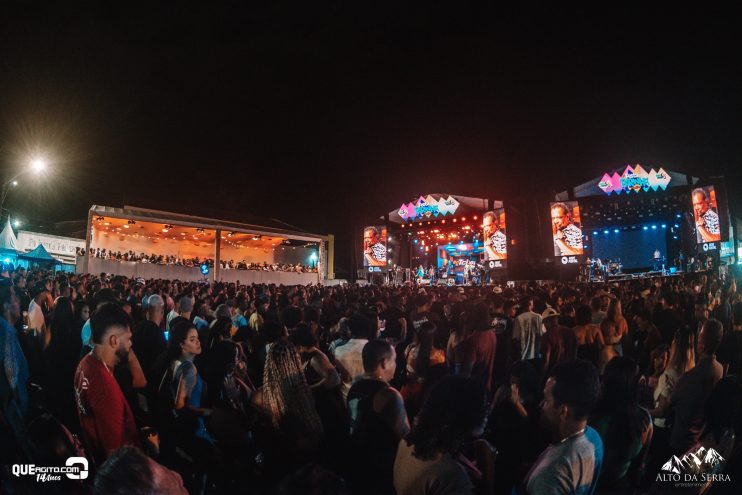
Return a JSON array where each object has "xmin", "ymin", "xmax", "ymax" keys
[{"xmin": 0, "ymin": 1, "xmax": 742, "ymax": 275}]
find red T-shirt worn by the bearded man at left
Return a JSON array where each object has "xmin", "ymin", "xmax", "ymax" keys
[{"xmin": 75, "ymin": 354, "xmax": 140, "ymax": 461}]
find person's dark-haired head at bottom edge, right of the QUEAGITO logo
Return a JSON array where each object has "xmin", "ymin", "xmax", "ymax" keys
[{"xmin": 93, "ymin": 446, "xmax": 188, "ymax": 495}]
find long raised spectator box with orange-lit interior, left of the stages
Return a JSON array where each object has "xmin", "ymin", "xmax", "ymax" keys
[{"xmin": 76, "ymin": 206, "xmax": 334, "ymax": 285}]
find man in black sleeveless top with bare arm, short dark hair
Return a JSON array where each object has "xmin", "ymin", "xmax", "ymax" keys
[{"xmin": 348, "ymin": 340, "xmax": 410, "ymax": 495}]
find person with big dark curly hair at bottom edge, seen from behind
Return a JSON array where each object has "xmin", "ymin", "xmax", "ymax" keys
[{"xmin": 394, "ymin": 376, "xmax": 487, "ymax": 495}]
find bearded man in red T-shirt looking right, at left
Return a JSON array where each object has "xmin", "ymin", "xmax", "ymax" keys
[{"xmin": 75, "ymin": 303, "xmax": 140, "ymax": 462}]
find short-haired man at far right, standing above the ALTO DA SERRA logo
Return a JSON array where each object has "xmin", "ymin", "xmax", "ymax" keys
[{"xmin": 670, "ymin": 319, "xmax": 724, "ymax": 454}]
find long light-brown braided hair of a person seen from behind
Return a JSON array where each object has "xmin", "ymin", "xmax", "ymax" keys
[{"xmin": 263, "ymin": 341, "xmax": 322, "ymax": 434}]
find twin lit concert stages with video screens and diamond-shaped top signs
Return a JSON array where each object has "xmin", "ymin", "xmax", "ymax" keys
[{"xmin": 355, "ymin": 165, "xmax": 736, "ymax": 285}]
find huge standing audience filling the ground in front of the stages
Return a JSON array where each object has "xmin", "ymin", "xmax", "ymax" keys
[{"xmin": 0, "ymin": 270, "xmax": 742, "ymax": 495}]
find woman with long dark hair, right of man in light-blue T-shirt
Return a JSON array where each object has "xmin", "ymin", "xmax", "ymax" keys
[{"xmin": 590, "ymin": 356, "xmax": 652, "ymax": 490}]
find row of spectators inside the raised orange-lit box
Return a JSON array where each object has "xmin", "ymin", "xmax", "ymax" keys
[{"xmin": 82, "ymin": 248, "xmax": 317, "ymax": 273}]
